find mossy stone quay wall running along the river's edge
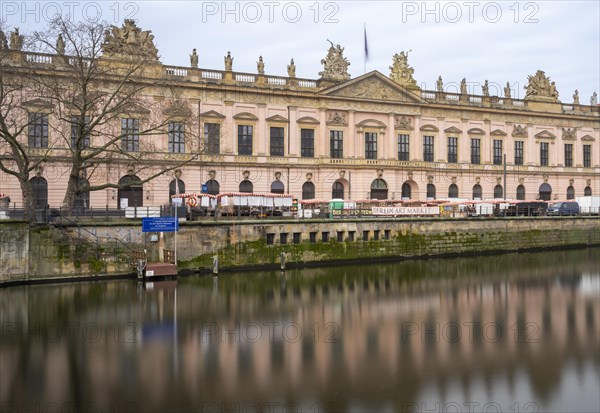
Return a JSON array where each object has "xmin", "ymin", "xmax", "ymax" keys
[{"xmin": 0, "ymin": 217, "xmax": 600, "ymax": 284}]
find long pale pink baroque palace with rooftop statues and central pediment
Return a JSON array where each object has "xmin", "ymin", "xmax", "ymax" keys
[{"xmin": 0, "ymin": 20, "xmax": 600, "ymax": 208}]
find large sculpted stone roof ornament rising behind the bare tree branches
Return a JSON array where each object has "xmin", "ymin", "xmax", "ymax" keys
[{"xmin": 102, "ymin": 19, "xmax": 158, "ymax": 62}]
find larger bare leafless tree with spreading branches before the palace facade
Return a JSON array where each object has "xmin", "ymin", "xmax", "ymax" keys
[{"xmin": 0, "ymin": 18, "xmax": 198, "ymax": 219}]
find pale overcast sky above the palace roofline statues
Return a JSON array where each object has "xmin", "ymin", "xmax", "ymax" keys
[{"xmin": 0, "ymin": 0, "xmax": 600, "ymax": 104}]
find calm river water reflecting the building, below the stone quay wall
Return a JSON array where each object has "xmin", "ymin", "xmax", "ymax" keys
[{"xmin": 0, "ymin": 248, "xmax": 600, "ymax": 413}]
